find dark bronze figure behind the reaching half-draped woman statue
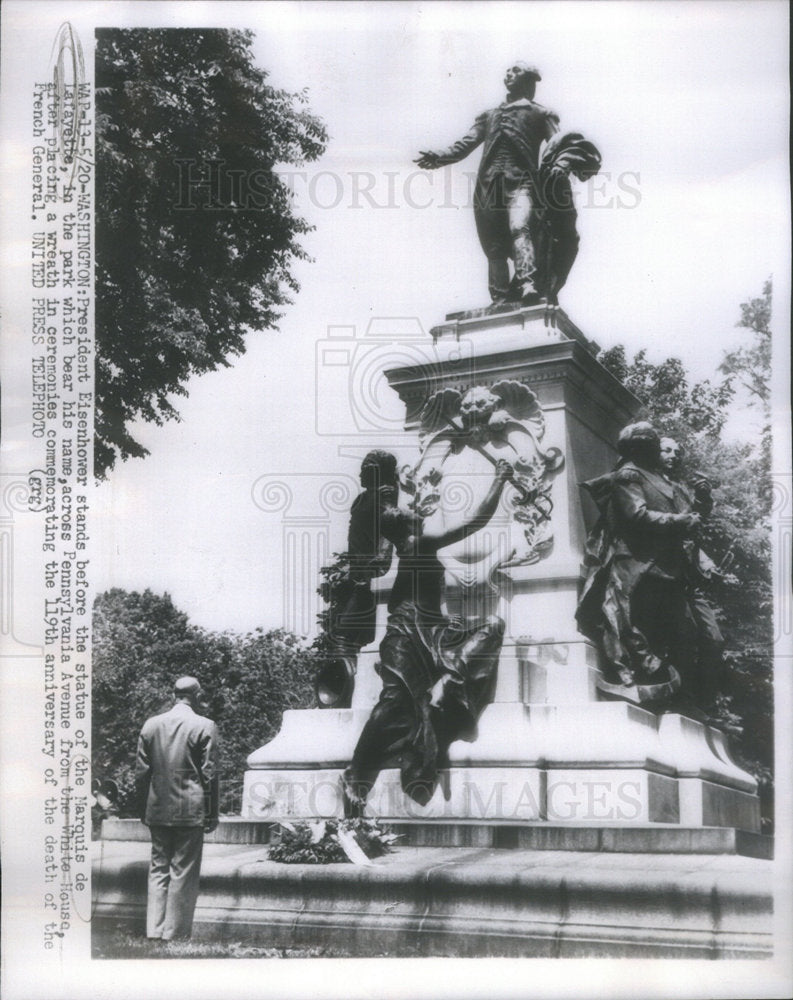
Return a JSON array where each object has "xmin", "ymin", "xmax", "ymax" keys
[{"xmin": 315, "ymin": 451, "xmax": 399, "ymax": 708}]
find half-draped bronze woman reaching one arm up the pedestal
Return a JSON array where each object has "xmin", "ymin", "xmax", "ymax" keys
[{"xmin": 342, "ymin": 461, "xmax": 513, "ymax": 816}]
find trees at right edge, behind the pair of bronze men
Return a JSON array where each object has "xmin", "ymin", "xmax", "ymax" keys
[{"xmin": 600, "ymin": 281, "xmax": 774, "ymax": 825}]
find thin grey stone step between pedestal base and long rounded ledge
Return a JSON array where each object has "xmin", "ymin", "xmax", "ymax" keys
[{"xmin": 96, "ymin": 817, "xmax": 774, "ymax": 860}]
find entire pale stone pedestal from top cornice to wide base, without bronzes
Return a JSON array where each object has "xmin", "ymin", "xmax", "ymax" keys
[{"xmin": 242, "ymin": 306, "xmax": 760, "ymax": 831}]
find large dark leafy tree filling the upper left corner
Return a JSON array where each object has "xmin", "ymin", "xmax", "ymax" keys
[{"xmin": 95, "ymin": 28, "xmax": 326, "ymax": 478}]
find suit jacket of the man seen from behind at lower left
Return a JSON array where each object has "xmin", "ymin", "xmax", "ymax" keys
[{"xmin": 135, "ymin": 702, "xmax": 218, "ymax": 826}]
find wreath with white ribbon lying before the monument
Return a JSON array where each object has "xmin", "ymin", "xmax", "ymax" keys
[{"xmin": 269, "ymin": 819, "xmax": 399, "ymax": 865}]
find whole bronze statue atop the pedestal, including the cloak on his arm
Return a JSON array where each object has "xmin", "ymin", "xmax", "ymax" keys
[{"xmin": 415, "ymin": 62, "xmax": 600, "ymax": 305}]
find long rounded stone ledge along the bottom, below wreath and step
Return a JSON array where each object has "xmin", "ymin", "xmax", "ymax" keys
[{"xmin": 92, "ymin": 821, "xmax": 773, "ymax": 959}]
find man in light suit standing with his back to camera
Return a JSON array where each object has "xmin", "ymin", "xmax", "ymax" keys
[{"xmin": 135, "ymin": 677, "xmax": 218, "ymax": 941}]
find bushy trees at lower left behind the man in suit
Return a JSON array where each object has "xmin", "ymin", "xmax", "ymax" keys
[{"xmin": 92, "ymin": 589, "xmax": 315, "ymax": 815}]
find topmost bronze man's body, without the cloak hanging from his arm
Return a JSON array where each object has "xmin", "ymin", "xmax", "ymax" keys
[{"xmin": 415, "ymin": 62, "xmax": 559, "ymax": 305}]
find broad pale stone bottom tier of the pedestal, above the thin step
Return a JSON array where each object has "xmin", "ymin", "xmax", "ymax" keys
[{"xmin": 242, "ymin": 702, "xmax": 760, "ymax": 832}]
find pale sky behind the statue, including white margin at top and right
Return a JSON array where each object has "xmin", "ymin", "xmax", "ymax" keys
[{"xmin": 94, "ymin": 0, "xmax": 789, "ymax": 631}]
